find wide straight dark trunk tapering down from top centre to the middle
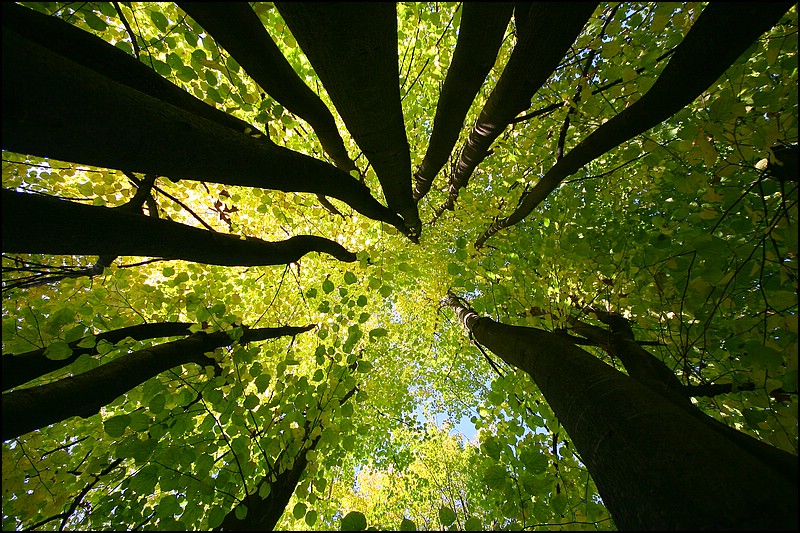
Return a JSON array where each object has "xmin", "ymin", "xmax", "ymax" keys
[{"xmin": 275, "ymin": 2, "xmax": 421, "ymax": 235}]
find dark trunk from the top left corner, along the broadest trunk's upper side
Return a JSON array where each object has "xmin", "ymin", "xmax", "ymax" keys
[{"xmin": 3, "ymin": 2, "xmax": 269, "ymax": 141}]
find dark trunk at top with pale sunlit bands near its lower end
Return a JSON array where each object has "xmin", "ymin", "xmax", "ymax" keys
[{"xmin": 444, "ymin": 2, "xmax": 597, "ymax": 210}]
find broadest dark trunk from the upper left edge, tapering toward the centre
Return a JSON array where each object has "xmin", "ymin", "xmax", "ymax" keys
[{"xmin": 2, "ymin": 27, "xmax": 404, "ymax": 231}]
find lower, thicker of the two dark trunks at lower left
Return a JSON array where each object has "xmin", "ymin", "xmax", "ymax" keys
[{"xmin": 3, "ymin": 324, "xmax": 314, "ymax": 441}]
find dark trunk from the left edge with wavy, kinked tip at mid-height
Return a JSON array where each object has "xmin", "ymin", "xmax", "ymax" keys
[{"xmin": 2, "ymin": 189, "xmax": 356, "ymax": 266}]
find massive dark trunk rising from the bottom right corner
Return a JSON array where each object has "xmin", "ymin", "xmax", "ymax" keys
[{"xmin": 447, "ymin": 297, "xmax": 798, "ymax": 530}]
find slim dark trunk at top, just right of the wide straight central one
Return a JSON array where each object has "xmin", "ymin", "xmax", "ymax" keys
[{"xmin": 414, "ymin": 2, "xmax": 514, "ymax": 202}]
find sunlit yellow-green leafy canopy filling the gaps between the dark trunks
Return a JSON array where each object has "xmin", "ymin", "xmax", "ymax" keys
[{"xmin": 2, "ymin": 2, "xmax": 798, "ymax": 530}]
